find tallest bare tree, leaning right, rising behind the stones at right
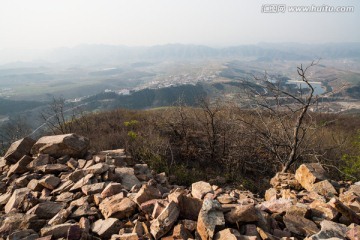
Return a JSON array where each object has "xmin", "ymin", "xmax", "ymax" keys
[{"xmin": 242, "ymin": 61, "xmax": 318, "ymax": 172}]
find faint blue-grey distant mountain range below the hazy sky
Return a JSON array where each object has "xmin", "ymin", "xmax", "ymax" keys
[{"xmin": 0, "ymin": 43, "xmax": 360, "ymax": 67}]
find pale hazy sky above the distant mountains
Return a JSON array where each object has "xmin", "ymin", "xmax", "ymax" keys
[{"xmin": 0, "ymin": 0, "xmax": 360, "ymax": 52}]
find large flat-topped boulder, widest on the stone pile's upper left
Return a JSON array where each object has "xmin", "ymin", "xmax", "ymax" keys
[{"xmin": 31, "ymin": 133, "xmax": 90, "ymax": 158}]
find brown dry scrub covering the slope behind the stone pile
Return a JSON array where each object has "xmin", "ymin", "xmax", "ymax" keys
[{"xmin": 57, "ymin": 102, "xmax": 360, "ymax": 189}]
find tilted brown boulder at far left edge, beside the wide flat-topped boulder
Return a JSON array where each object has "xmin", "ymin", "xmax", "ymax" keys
[{"xmin": 4, "ymin": 137, "xmax": 35, "ymax": 164}]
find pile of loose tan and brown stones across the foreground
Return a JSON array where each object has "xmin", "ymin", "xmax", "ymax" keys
[{"xmin": 0, "ymin": 134, "xmax": 360, "ymax": 240}]
